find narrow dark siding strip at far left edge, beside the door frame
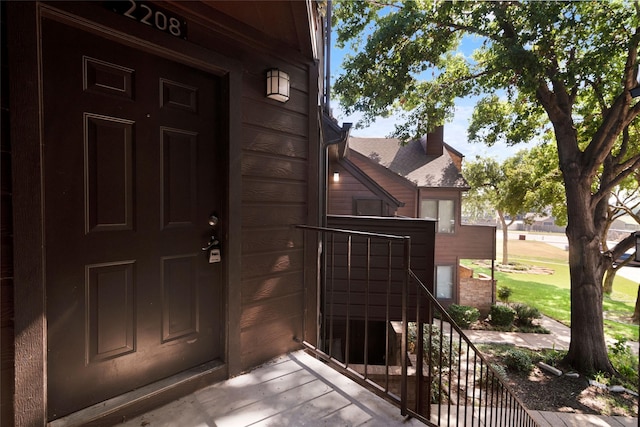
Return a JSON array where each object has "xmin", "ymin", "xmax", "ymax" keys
[{"xmin": 0, "ymin": 2, "xmax": 14, "ymax": 426}]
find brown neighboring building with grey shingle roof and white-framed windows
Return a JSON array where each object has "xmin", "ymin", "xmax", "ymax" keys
[{"xmin": 328, "ymin": 127, "xmax": 496, "ymax": 311}]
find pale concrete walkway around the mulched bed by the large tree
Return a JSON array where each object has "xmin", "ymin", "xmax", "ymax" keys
[{"xmin": 464, "ymin": 317, "xmax": 638, "ymax": 427}]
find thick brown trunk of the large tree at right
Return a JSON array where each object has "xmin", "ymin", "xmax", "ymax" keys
[{"xmin": 563, "ymin": 160, "xmax": 615, "ymax": 373}]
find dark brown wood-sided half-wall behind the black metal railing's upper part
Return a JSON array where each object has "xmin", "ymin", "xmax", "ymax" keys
[{"xmin": 326, "ymin": 216, "xmax": 435, "ymax": 320}]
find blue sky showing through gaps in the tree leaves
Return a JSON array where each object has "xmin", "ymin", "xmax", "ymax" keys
[{"xmin": 331, "ymin": 31, "xmax": 526, "ymax": 161}]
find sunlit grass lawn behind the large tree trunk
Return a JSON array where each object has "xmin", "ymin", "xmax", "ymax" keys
[{"xmin": 465, "ymin": 240, "xmax": 638, "ymax": 341}]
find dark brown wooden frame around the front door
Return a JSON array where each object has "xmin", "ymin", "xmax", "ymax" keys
[{"xmin": 7, "ymin": 2, "xmax": 242, "ymax": 426}]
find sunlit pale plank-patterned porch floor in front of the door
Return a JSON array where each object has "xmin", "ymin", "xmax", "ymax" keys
[{"xmin": 119, "ymin": 351, "xmax": 424, "ymax": 427}]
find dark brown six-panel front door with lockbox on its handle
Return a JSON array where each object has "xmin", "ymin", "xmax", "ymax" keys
[{"xmin": 40, "ymin": 19, "xmax": 225, "ymax": 419}]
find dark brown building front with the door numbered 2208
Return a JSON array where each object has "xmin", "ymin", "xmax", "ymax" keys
[{"xmin": 0, "ymin": 0, "xmax": 326, "ymax": 426}]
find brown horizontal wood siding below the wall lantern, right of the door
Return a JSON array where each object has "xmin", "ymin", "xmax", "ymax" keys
[{"xmin": 240, "ymin": 64, "xmax": 317, "ymax": 368}]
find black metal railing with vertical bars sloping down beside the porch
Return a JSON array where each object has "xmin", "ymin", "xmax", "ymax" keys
[{"xmin": 300, "ymin": 226, "xmax": 537, "ymax": 426}]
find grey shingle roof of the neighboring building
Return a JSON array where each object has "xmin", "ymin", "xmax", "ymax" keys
[{"xmin": 349, "ymin": 136, "xmax": 469, "ymax": 188}]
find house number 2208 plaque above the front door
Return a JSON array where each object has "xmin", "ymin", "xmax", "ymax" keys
[{"xmin": 109, "ymin": 0, "xmax": 187, "ymax": 38}]
